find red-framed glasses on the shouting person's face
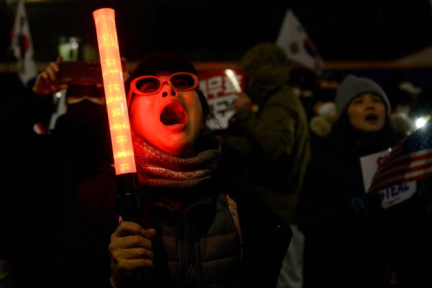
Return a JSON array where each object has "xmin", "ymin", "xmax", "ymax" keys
[{"xmin": 130, "ymin": 72, "xmax": 199, "ymax": 96}]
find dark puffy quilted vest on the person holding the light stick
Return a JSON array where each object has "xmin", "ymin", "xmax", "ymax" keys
[{"xmin": 146, "ymin": 193, "xmax": 242, "ymax": 288}]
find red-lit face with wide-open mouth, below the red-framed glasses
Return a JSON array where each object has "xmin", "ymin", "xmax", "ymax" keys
[{"xmin": 130, "ymin": 83, "xmax": 204, "ymax": 156}]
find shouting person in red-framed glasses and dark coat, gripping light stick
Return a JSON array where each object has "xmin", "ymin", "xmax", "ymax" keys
[{"xmin": 58, "ymin": 52, "xmax": 292, "ymax": 288}]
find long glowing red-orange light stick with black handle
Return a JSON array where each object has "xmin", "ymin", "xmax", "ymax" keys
[{"xmin": 93, "ymin": 8, "xmax": 142, "ymax": 223}]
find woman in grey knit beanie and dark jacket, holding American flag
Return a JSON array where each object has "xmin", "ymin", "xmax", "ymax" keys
[{"xmin": 298, "ymin": 75, "xmax": 403, "ymax": 288}]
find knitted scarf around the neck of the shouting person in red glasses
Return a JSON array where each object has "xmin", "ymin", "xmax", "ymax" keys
[{"xmin": 132, "ymin": 134, "xmax": 221, "ymax": 189}]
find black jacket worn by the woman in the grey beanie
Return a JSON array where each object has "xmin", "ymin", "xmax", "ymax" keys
[{"xmin": 298, "ymin": 118, "xmax": 404, "ymax": 288}]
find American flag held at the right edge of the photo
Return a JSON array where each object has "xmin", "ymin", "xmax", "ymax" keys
[{"xmin": 369, "ymin": 120, "xmax": 432, "ymax": 192}]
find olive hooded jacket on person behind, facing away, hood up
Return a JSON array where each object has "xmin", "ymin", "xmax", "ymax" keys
[{"xmin": 221, "ymin": 43, "xmax": 310, "ymax": 223}]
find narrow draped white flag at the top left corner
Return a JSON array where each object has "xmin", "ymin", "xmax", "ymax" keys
[{"xmin": 11, "ymin": 0, "xmax": 37, "ymax": 84}]
